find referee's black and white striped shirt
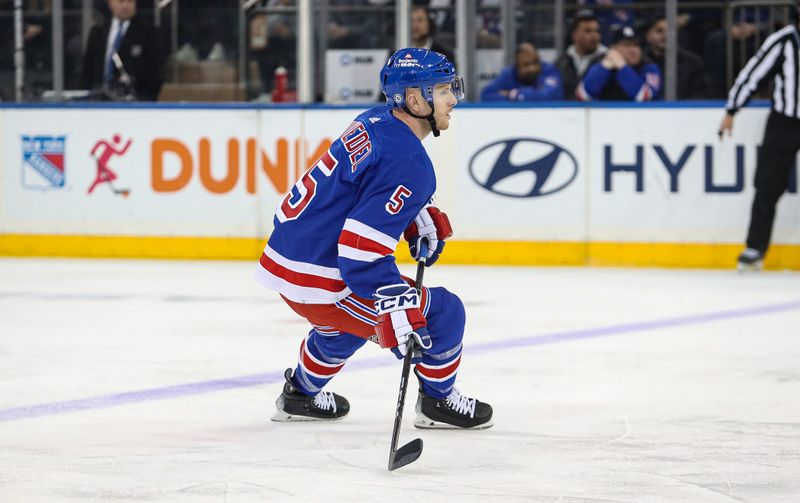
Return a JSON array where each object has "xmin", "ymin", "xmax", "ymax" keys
[{"xmin": 725, "ymin": 24, "xmax": 800, "ymax": 118}]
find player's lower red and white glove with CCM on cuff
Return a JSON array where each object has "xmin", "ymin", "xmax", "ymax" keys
[{"xmin": 374, "ymin": 283, "xmax": 431, "ymax": 358}]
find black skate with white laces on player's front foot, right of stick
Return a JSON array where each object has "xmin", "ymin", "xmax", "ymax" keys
[{"xmin": 414, "ymin": 388, "xmax": 494, "ymax": 430}]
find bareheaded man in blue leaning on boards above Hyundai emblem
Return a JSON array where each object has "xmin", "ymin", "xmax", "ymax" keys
[{"xmin": 481, "ymin": 42, "xmax": 564, "ymax": 101}]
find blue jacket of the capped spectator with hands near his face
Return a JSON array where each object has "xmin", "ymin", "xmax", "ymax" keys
[{"xmin": 575, "ymin": 60, "xmax": 663, "ymax": 101}]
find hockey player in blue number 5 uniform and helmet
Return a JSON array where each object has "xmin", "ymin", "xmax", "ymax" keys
[{"xmin": 257, "ymin": 48, "xmax": 492, "ymax": 429}]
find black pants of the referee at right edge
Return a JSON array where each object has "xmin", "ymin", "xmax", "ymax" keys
[{"xmin": 747, "ymin": 110, "xmax": 800, "ymax": 254}]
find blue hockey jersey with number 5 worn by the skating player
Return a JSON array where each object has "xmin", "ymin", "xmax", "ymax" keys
[{"xmin": 257, "ymin": 106, "xmax": 436, "ymax": 304}]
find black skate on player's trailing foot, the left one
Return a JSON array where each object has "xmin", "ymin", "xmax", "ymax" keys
[{"xmin": 272, "ymin": 369, "xmax": 350, "ymax": 422}]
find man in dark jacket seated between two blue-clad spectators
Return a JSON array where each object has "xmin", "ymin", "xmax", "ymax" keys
[{"xmin": 556, "ymin": 9, "xmax": 608, "ymax": 100}]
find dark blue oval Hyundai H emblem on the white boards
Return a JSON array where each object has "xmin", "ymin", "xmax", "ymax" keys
[{"xmin": 469, "ymin": 138, "xmax": 578, "ymax": 201}]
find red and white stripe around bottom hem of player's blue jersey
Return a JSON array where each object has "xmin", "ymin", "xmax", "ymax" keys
[{"xmin": 256, "ymin": 244, "xmax": 351, "ymax": 304}]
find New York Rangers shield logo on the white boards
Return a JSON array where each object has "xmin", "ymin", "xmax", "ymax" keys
[{"xmin": 22, "ymin": 135, "xmax": 66, "ymax": 189}]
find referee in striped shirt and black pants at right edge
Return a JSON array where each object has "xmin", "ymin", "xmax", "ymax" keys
[{"xmin": 719, "ymin": 2, "xmax": 800, "ymax": 271}]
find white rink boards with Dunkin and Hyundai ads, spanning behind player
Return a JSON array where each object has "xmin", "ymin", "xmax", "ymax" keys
[{"xmin": 0, "ymin": 106, "xmax": 800, "ymax": 253}]
